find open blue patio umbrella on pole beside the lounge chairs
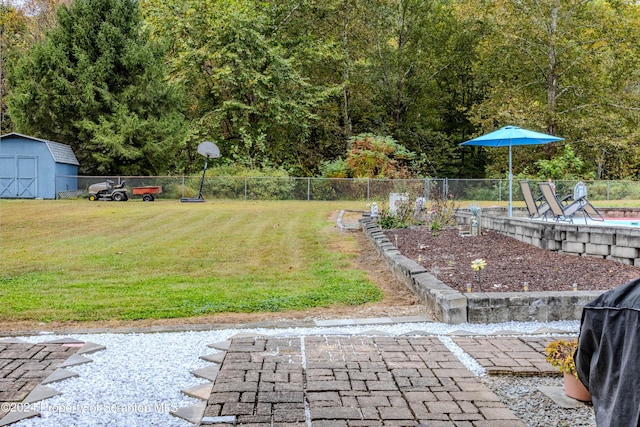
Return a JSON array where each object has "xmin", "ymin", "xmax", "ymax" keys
[{"xmin": 460, "ymin": 126, "xmax": 564, "ymax": 216}]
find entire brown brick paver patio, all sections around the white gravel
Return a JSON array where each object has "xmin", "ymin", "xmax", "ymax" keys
[{"xmin": 0, "ymin": 331, "xmax": 584, "ymax": 427}]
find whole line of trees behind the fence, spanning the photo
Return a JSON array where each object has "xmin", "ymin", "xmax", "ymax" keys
[{"xmin": 0, "ymin": 0, "xmax": 640, "ymax": 179}]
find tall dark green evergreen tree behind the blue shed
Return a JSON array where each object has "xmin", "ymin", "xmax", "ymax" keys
[{"xmin": 7, "ymin": 0, "xmax": 182, "ymax": 175}]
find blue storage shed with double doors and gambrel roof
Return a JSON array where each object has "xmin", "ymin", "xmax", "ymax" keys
[{"xmin": 0, "ymin": 132, "xmax": 79, "ymax": 199}]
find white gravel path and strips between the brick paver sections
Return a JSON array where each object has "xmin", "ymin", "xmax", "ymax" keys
[{"xmin": 8, "ymin": 321, "xmax": 579, "ymax": 427}]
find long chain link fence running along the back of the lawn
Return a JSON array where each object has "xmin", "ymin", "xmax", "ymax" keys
[{"xmin": 56, "ymin": 176, "xmax": 640, "ymax": 202}]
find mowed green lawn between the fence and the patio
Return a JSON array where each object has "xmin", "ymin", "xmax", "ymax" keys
[{"xmin": 0, "ymin": 200, "xmax": 382, "ymax": 322}]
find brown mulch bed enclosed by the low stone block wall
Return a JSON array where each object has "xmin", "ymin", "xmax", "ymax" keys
[{"xmin": 385, "ymin": 227, "xmax": 640, "ymax": 292}]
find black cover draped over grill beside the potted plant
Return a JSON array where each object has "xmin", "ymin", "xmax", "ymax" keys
[{"xmin": 575, "ymin": 279, "xmax": 640, "ymax": 427}]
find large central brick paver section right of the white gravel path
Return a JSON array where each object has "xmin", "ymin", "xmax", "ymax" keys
[{"xmin": 204, "ymin": 336, "xmax": 524, "ymax": 427}]
